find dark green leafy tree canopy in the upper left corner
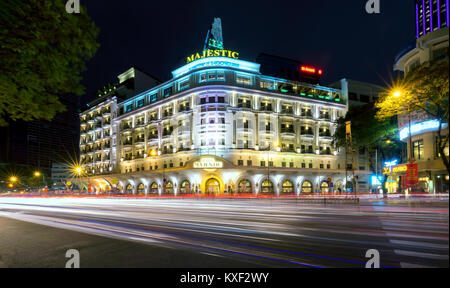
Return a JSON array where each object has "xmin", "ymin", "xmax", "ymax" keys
[{"xmin": 0, "ymin": 0, "xmax": 99, "ymax": 126}]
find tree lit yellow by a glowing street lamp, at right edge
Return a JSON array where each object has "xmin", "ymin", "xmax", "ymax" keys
[{"xmin": 376, "ymin": 59, "xmax": 450, "ymax": 173}]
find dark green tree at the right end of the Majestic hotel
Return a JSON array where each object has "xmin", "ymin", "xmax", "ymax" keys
[{"xmin": 333, "ymin": 103, "xmax": 405, "ymax": 191}]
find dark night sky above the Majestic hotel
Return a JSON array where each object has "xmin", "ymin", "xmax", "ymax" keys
[{"xmin": 81, "ymin": 0, "xmax": 415, "ymax": 104}]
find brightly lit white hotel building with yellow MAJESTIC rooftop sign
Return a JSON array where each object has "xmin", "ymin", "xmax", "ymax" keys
[{"xmin": 80, "ymin": 20, "xmax": 368, "ymax": 195}]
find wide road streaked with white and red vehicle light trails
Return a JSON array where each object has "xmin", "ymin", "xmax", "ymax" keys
[{"xmin": 0, "ymin": 198, "xmax": 449, "ymax": 268}]
